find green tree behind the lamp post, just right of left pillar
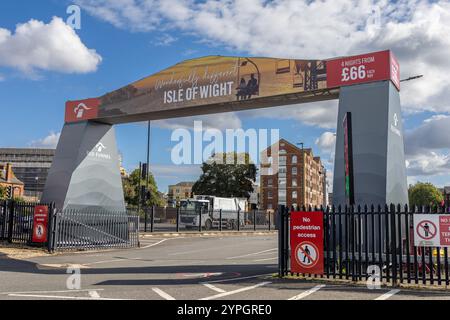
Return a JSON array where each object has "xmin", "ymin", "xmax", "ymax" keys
[{"xmin": 122, "ymin": 169, "xmax": 163, "ymax": 206}]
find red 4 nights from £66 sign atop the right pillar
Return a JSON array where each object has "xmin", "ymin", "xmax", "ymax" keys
[{"xmin": 327, "ymin": 50, "xmax": 400, "ymax": 90}]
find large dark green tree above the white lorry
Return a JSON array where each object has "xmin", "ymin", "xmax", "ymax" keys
[{"xmin": 192, "ymin": 153, "xmax": 258, "ymax": 198}]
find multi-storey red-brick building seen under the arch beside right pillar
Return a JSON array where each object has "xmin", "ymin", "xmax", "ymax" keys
[{"xmin": 260, "ymin": 139, "xmax": 327, "ymax": 209}]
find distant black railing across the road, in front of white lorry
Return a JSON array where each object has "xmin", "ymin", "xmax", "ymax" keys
[{"xmin": 127, "ymin": 206, "xmax": 276, "ymax": 232}]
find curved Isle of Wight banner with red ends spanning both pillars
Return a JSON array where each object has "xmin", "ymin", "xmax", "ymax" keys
[{"xmin": 65, "ymin": 51, "xmax": 398, "ymax": 124}]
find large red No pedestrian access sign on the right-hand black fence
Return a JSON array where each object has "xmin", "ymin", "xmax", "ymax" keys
[{"xmin": 290, "ymin": 211, "xmax": 324, "ymax": 274}]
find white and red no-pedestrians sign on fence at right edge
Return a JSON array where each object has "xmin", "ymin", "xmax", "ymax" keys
[{"xmin": 414, "ymin": 214, "xmax": 450, "ymax": 247}]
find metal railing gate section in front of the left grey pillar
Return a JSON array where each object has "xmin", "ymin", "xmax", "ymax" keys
[{"xmin": 51, "ymin": 210, "xmax": 139, "ymax": 251}]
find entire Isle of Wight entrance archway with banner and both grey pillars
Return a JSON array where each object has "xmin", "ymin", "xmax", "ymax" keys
[{"xmin": 42, "ymin": 50, "xmax": 408, "ymax": 211}]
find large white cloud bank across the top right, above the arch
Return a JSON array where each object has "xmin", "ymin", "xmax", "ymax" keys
[{"xmin": 77, "ymin": 0, "xmax": 450, "ymax": 116}]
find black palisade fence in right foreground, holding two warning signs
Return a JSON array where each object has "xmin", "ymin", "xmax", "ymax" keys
[{"xmin": 279, "ymin": 205, "xmax": 450, "ymax": 286}]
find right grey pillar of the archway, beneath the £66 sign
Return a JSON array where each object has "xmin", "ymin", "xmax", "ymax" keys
[{"xmin": 333, "ymin": 81, "xmax": 408, "ymax": 205}]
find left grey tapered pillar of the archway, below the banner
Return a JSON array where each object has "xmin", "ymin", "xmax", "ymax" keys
[{"xmin": 42, "ymin": 121, "xmax": 125, "ymax": 212}]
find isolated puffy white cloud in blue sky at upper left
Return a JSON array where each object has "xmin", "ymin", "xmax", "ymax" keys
[{"xmin": 0, "ymin": 17, "xmax": 102, "ymax": 74}]
